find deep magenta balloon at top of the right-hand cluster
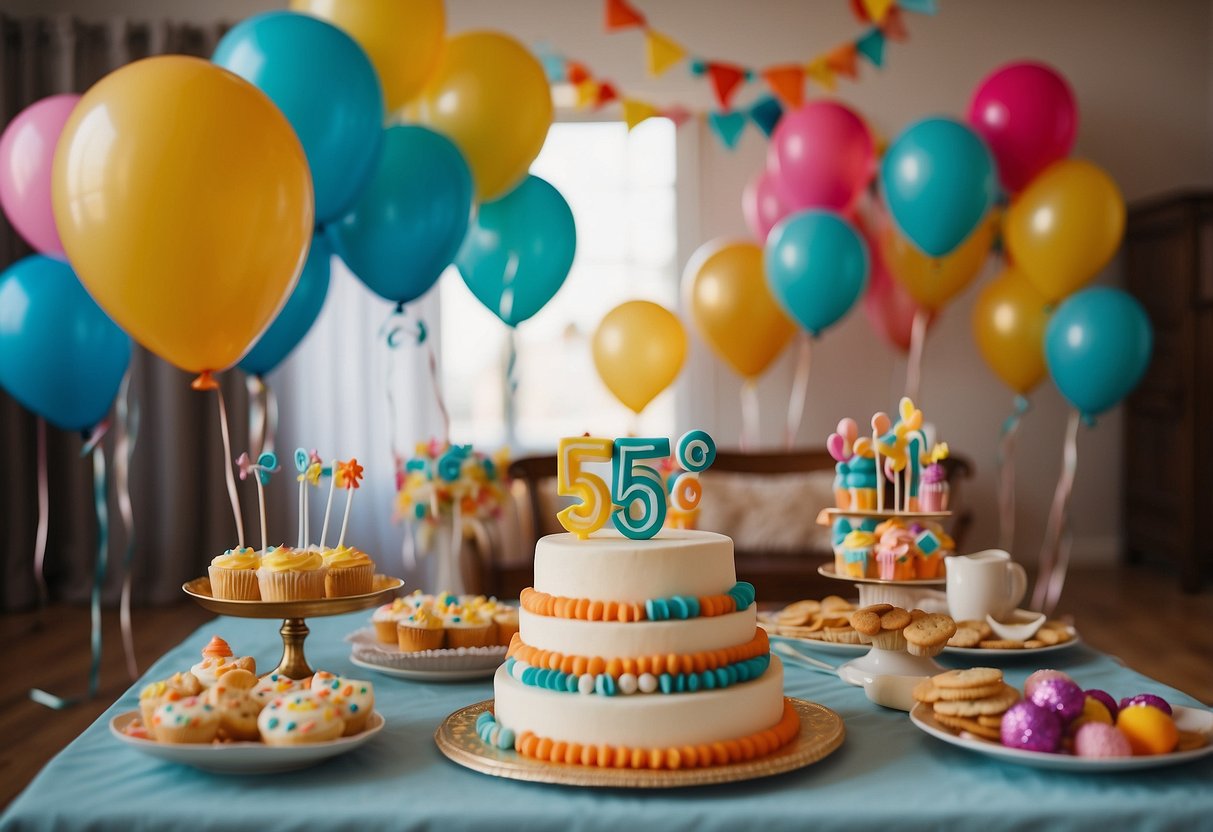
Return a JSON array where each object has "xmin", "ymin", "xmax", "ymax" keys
[{"xmin": 968, "ymin": 61, "xmax": 1078, "ymax": 193}]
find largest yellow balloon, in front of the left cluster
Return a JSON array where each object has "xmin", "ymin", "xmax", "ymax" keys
[{"xmin": 51, "ymin": 56, "xmax": 313, "ymax": 372}]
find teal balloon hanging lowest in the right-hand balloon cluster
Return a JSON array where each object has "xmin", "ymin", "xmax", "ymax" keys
[{"xmin": 1044, "ymin": 286, "xmax": 1154, "ymax": 418}]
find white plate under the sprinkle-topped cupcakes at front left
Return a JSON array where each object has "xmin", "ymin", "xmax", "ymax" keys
[{"xmin": 109, "ymin": 711, "xmax": 385, "ymax": 774}]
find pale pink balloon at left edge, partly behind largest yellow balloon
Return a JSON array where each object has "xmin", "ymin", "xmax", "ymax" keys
[{"xmin": 0, "ymin": 96, "xmax": 80, "ymax": 260}]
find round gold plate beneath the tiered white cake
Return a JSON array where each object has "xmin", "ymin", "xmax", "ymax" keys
[{"xmin": 434, "ymin": 697, "xmax": 847, "ymax": 788}]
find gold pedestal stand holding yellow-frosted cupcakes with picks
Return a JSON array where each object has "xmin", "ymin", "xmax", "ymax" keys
[{"xmin": 181, "ymin": 575, "xmax": 404, "ymax": 679}]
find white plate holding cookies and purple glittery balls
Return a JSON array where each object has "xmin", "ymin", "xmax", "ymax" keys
[{"xmin": 910, "ymin": 703, "xmax": 1213, "ymax": 773}]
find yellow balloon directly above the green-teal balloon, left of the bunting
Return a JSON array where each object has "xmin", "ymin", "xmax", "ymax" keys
[{"xmin": 405, "ymin": 32, "xmax": 552, "ymax": 203}]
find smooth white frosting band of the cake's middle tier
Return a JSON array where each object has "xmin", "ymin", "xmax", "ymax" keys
[{"xmin": 518, "ymin": 605, "xmax": 758, "ymax": 659}]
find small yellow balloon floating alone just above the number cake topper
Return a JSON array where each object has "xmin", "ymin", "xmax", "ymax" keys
[{"xmin": 593, "ymin": 301, "xmax": 687, "ymax": 414}]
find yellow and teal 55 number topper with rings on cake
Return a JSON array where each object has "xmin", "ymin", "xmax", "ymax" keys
[{"xmin": 557, "ymin": 431, "xmax": 716, "ymax": 540}]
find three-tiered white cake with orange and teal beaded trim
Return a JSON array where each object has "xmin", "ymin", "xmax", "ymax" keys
[{"xmin": 479, "ymin": 530, "xmax": 799, "ymax": 768}]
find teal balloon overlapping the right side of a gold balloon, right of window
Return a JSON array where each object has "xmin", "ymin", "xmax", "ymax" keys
[{"xmin": 763, "ymin": 210, "xmax": 869, "ymax": 336}]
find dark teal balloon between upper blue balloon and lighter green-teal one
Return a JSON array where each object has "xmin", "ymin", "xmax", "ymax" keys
[{"xmin": 326, "ymin": 125, "xmax": 472, "ymax": 303}]
